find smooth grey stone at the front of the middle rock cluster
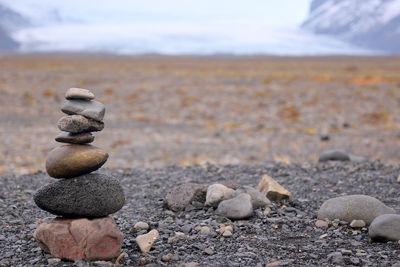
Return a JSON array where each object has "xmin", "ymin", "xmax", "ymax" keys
[{"xmin": 216, "ymin": 193, "xmax": 253, "ymax": 219}]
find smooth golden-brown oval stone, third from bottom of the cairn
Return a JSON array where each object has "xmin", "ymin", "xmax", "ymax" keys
[{"xmin": 46, "ymin": 144, "xmax": 108, "ymax": 178}]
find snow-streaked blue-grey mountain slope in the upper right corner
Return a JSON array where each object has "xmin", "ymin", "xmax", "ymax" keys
[{"xmin": 302, "ymin": 0, "xmax": 400, "ymax": 53}]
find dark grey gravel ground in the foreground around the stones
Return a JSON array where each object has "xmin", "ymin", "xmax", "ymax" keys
[{"xmin": 0, "ymin": 162, "xmax": 400, "ymax": 266}]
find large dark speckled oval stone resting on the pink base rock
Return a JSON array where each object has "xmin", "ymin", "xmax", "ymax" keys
[{"xmin": 33, "ymin": 173, "xmax": 125, "ymax": 218}]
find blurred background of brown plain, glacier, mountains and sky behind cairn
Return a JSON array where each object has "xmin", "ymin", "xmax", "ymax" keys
[{"xmin": 0, "ymin": 0, "xmax": 400, "ymax": 174}]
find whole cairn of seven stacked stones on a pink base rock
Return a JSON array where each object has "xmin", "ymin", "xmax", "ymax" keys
[{"xmin": 33, "ymin": 88, "xmax": 125, "ymax": 260}]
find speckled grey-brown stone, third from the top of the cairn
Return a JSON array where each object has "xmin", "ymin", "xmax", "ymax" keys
[{"xmin": 57, "ymin": 115, "xmax": 104, "ymax": 134}]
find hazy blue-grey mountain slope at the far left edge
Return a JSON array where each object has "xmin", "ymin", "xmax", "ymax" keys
[{"xmin": 0, "ymin": 3, "xmax": 29, "ymax": 51}]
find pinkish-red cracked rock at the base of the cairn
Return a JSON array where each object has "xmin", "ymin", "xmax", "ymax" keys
[{"xmin": 33, "ymin": 217, "xmax": 123, "ymax": 260}]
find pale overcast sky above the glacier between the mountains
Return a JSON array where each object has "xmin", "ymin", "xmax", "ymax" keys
[{"xmin": 1, "ymin": 0, "xmax": 311, "ymax": 27}]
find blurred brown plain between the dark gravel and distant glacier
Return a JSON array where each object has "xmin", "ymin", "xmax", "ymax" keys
[{"xmin": 0, "ymin": 54, "xmax": 400, "ymax": 174}]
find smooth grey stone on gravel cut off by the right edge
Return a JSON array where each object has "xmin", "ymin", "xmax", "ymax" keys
[{"xmin": 369, "ymin": 214, "xmax": 400, "ymax": 241}]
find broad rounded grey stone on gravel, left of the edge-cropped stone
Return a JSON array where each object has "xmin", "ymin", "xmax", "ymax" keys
[{"xmin": 318, "ymin": 195, "xmax": 396, "ymax": 225}]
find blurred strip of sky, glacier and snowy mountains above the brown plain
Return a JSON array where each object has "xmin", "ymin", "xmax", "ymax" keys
[{"xmin": 0, "ymin": 0, "xmax": 400, "ymax": 55}]
